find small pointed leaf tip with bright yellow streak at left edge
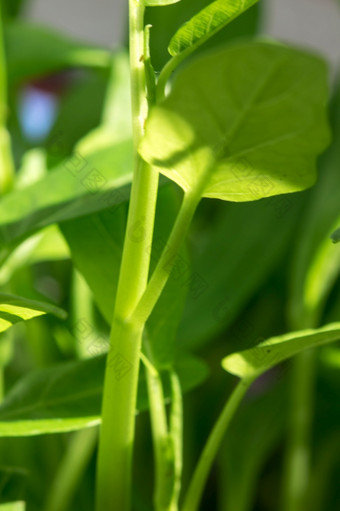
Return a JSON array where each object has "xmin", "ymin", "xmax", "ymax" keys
[{"xmin": 0, "ymin": 293, "xmax": 66, "ymax": 332}]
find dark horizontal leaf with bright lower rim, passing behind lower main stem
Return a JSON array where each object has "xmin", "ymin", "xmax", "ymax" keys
[{"xmin": 0, "ymin": 356, "xmax": 207, "ymax": 437}]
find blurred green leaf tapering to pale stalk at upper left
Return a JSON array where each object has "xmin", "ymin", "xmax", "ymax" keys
[{"xmin": 5, "ymin": 21, "xmax": 110, "ymax": 83}]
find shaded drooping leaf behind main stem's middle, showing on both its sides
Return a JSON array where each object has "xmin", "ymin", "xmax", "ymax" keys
[{"xmin": 61, "ymin": 183, "xmax": 191, "ymax": 369}]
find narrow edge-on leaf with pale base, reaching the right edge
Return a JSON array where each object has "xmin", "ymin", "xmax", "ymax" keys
[{"xmin": 222, "ymin": 323, "xmax": 340, "ymax": 378}]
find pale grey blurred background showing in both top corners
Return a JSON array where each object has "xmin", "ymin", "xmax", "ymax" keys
[{"xmin": 27, "ymin": 0, "xmax": 340, "ymax": 63}]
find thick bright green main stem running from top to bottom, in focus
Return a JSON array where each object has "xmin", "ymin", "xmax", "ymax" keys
[{"xmin": 96, "ymin": 0, "xmax": 158, "ymax": 511}]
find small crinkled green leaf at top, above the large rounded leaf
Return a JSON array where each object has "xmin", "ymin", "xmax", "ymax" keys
[{"xmin": 169, "ymin": 0, "xmax": 258, "ymax": 56}]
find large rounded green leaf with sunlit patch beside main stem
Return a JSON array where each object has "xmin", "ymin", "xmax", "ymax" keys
[{"xmin": 140, "ymin": 42, "xmax": 329, "ymax": 202}]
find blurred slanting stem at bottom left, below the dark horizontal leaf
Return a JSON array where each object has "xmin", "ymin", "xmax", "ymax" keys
[{"xmin": 44, "ymin": 428, "xmax": 98, "ymax": 511}]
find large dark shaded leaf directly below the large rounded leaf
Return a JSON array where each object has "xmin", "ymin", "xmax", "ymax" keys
[{"xmin": 179, "ymin": 195, "xmax": 301, "ymax": 348}]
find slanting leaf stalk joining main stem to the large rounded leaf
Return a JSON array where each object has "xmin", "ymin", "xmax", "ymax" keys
[{"xmin": 131, "ymin": 193, "xmax": 201, "ymax": 324}]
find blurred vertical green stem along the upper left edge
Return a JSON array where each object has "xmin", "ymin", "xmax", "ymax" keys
[{"xmin": 0, "ymin": 3, "xmax": 14, "ymax": 195}]
